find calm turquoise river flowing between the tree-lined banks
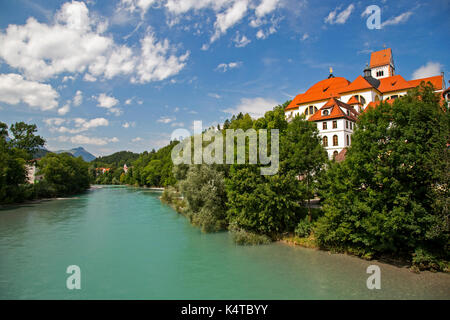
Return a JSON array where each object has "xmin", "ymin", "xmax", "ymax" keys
[{"xmin": 0, "ymin": 187, "xmax": 450, "ymax": 299}]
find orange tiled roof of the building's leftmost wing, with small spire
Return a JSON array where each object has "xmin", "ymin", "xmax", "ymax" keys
[{"xmin": 286, "ymin": 77, "xmax": 350, "ymax": 110}]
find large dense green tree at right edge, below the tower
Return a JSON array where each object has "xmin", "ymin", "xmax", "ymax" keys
[{"xmin": 316, "ymin": 85, "xmax": 450, "ymax": 266}]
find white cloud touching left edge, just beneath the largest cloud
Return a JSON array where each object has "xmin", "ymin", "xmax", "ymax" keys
[{"xmin": 0, "ymin": 74, "xmax": 59, "ymax": 111}]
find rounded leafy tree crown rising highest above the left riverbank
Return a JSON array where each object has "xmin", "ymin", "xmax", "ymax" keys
[{"xmin": 8, "ymin": 122, "xmax": 45, "ymax": 158}]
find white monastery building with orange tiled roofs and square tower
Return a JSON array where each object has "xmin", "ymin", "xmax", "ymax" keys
[{"xmin": 285, "ymin": 48, "xmax": 450, "ymax": 158}]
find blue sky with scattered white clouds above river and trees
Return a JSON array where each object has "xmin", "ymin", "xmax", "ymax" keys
[{"xmin": 0, "ymin": 0, "xmax": 450, "ymax": 156}]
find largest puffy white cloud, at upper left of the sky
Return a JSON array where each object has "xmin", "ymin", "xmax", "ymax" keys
[{"xmin": 0, "ymin": 0, "xmax": 188, "ymax": 82}]
